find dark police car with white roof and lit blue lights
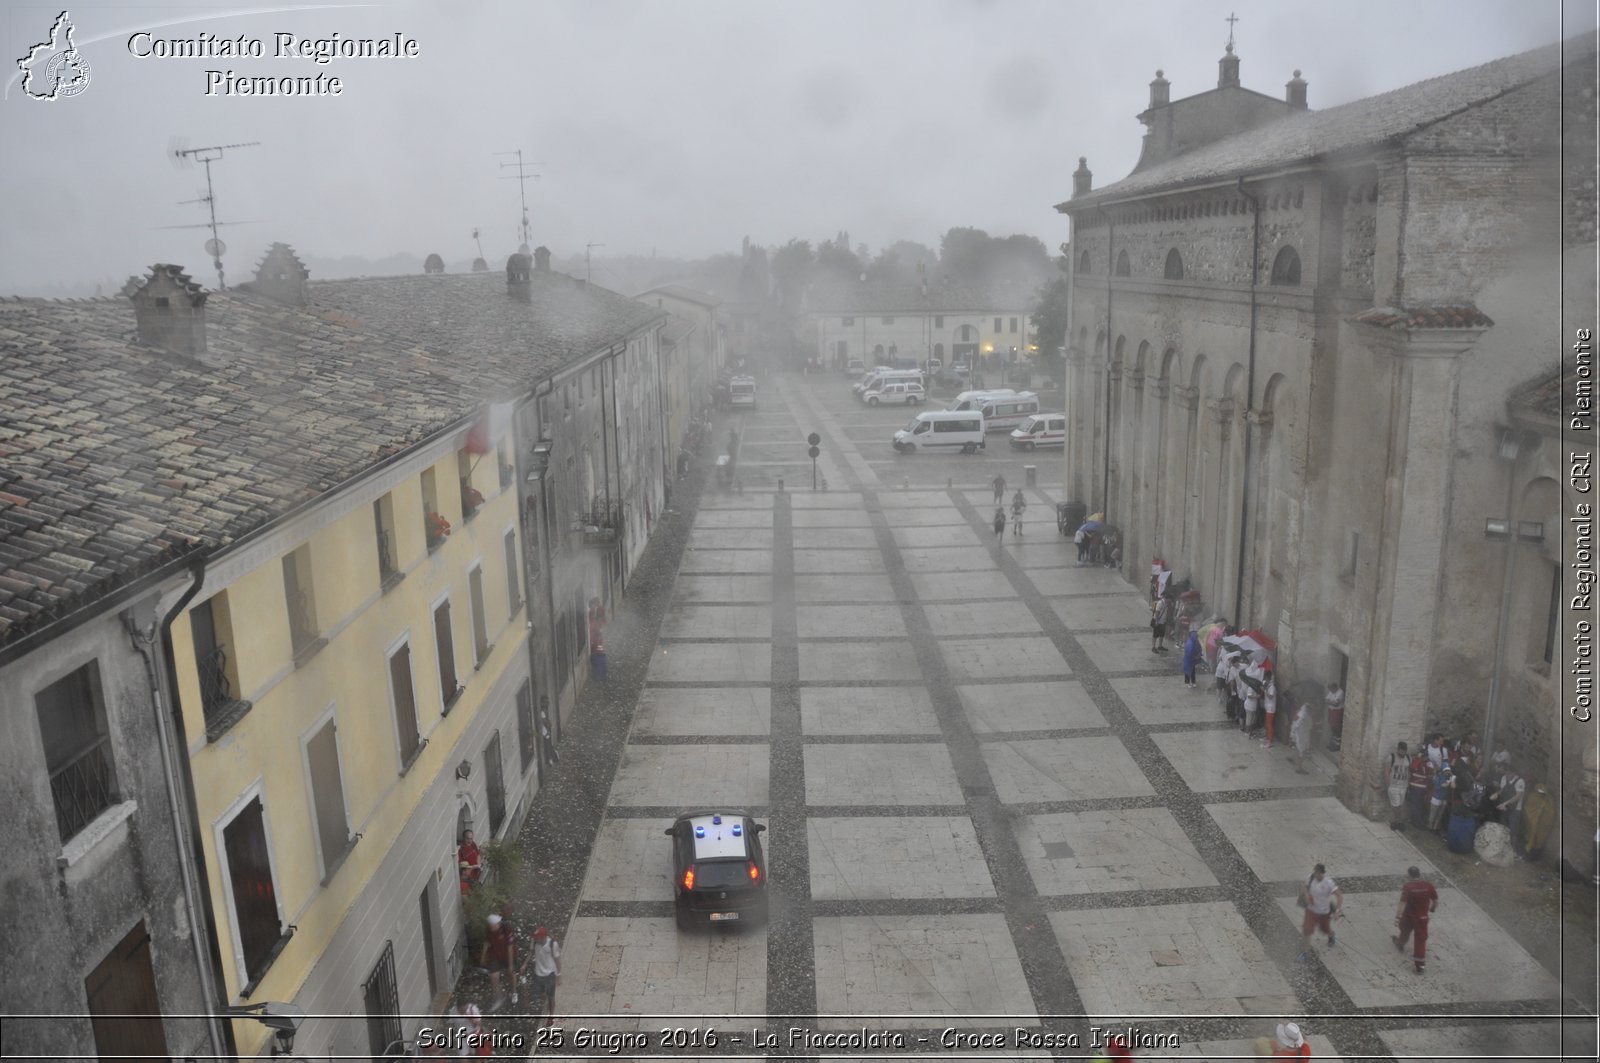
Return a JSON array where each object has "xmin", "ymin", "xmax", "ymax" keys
[{"xmin": 666, "ymin": 812, "xmax": 766, "ymax": 929}]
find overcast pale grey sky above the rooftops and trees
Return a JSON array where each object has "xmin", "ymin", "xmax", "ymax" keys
[{"xmin": 0, "ymin": 0, "xmax": 1595, "ymax": 293}]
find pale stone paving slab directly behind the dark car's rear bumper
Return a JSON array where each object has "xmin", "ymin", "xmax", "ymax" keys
[{"xmin": 555, "ymin": 915, "xmax": 766, "ymax": 1036}]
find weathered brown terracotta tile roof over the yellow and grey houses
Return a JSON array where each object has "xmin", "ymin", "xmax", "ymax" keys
[{"xmin": 0, "ymin": 274, "xmax": 662, "ymax": 647}]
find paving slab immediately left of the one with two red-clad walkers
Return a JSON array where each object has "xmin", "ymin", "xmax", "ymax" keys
[{"xmin": 1050, "ymin": 901, "xmax": 1304, "ymax": 1017}]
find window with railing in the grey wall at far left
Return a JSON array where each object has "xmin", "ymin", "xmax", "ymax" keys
[{"xmin": 34, "ymin": 661, "xmax": 118, "ymax": 842}]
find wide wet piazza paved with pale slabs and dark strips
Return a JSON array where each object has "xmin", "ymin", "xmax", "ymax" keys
[{"xmin": 562, "ymin": 376, "xmax": 1594, "ymax": 1060}]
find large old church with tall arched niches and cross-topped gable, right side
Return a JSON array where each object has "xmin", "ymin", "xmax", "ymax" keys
[{"xmin": 1058, "ymin": 34, "xmax": 1595, "ymax": 861}]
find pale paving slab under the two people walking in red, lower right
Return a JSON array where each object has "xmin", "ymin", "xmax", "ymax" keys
[{"xmin": 1277, "ymin": 890, "xmax": 1561, "ymax": 1007}]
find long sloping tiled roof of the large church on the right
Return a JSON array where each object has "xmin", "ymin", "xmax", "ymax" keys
[{"xmin": 1056, "ymin": 32, "xmax": 1597, "ymax": 213}]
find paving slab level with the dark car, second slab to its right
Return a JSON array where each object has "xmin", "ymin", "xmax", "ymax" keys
[{"xmin": 1013, "ymin": 808, "xmax": 1216, "ymax": 897}]
